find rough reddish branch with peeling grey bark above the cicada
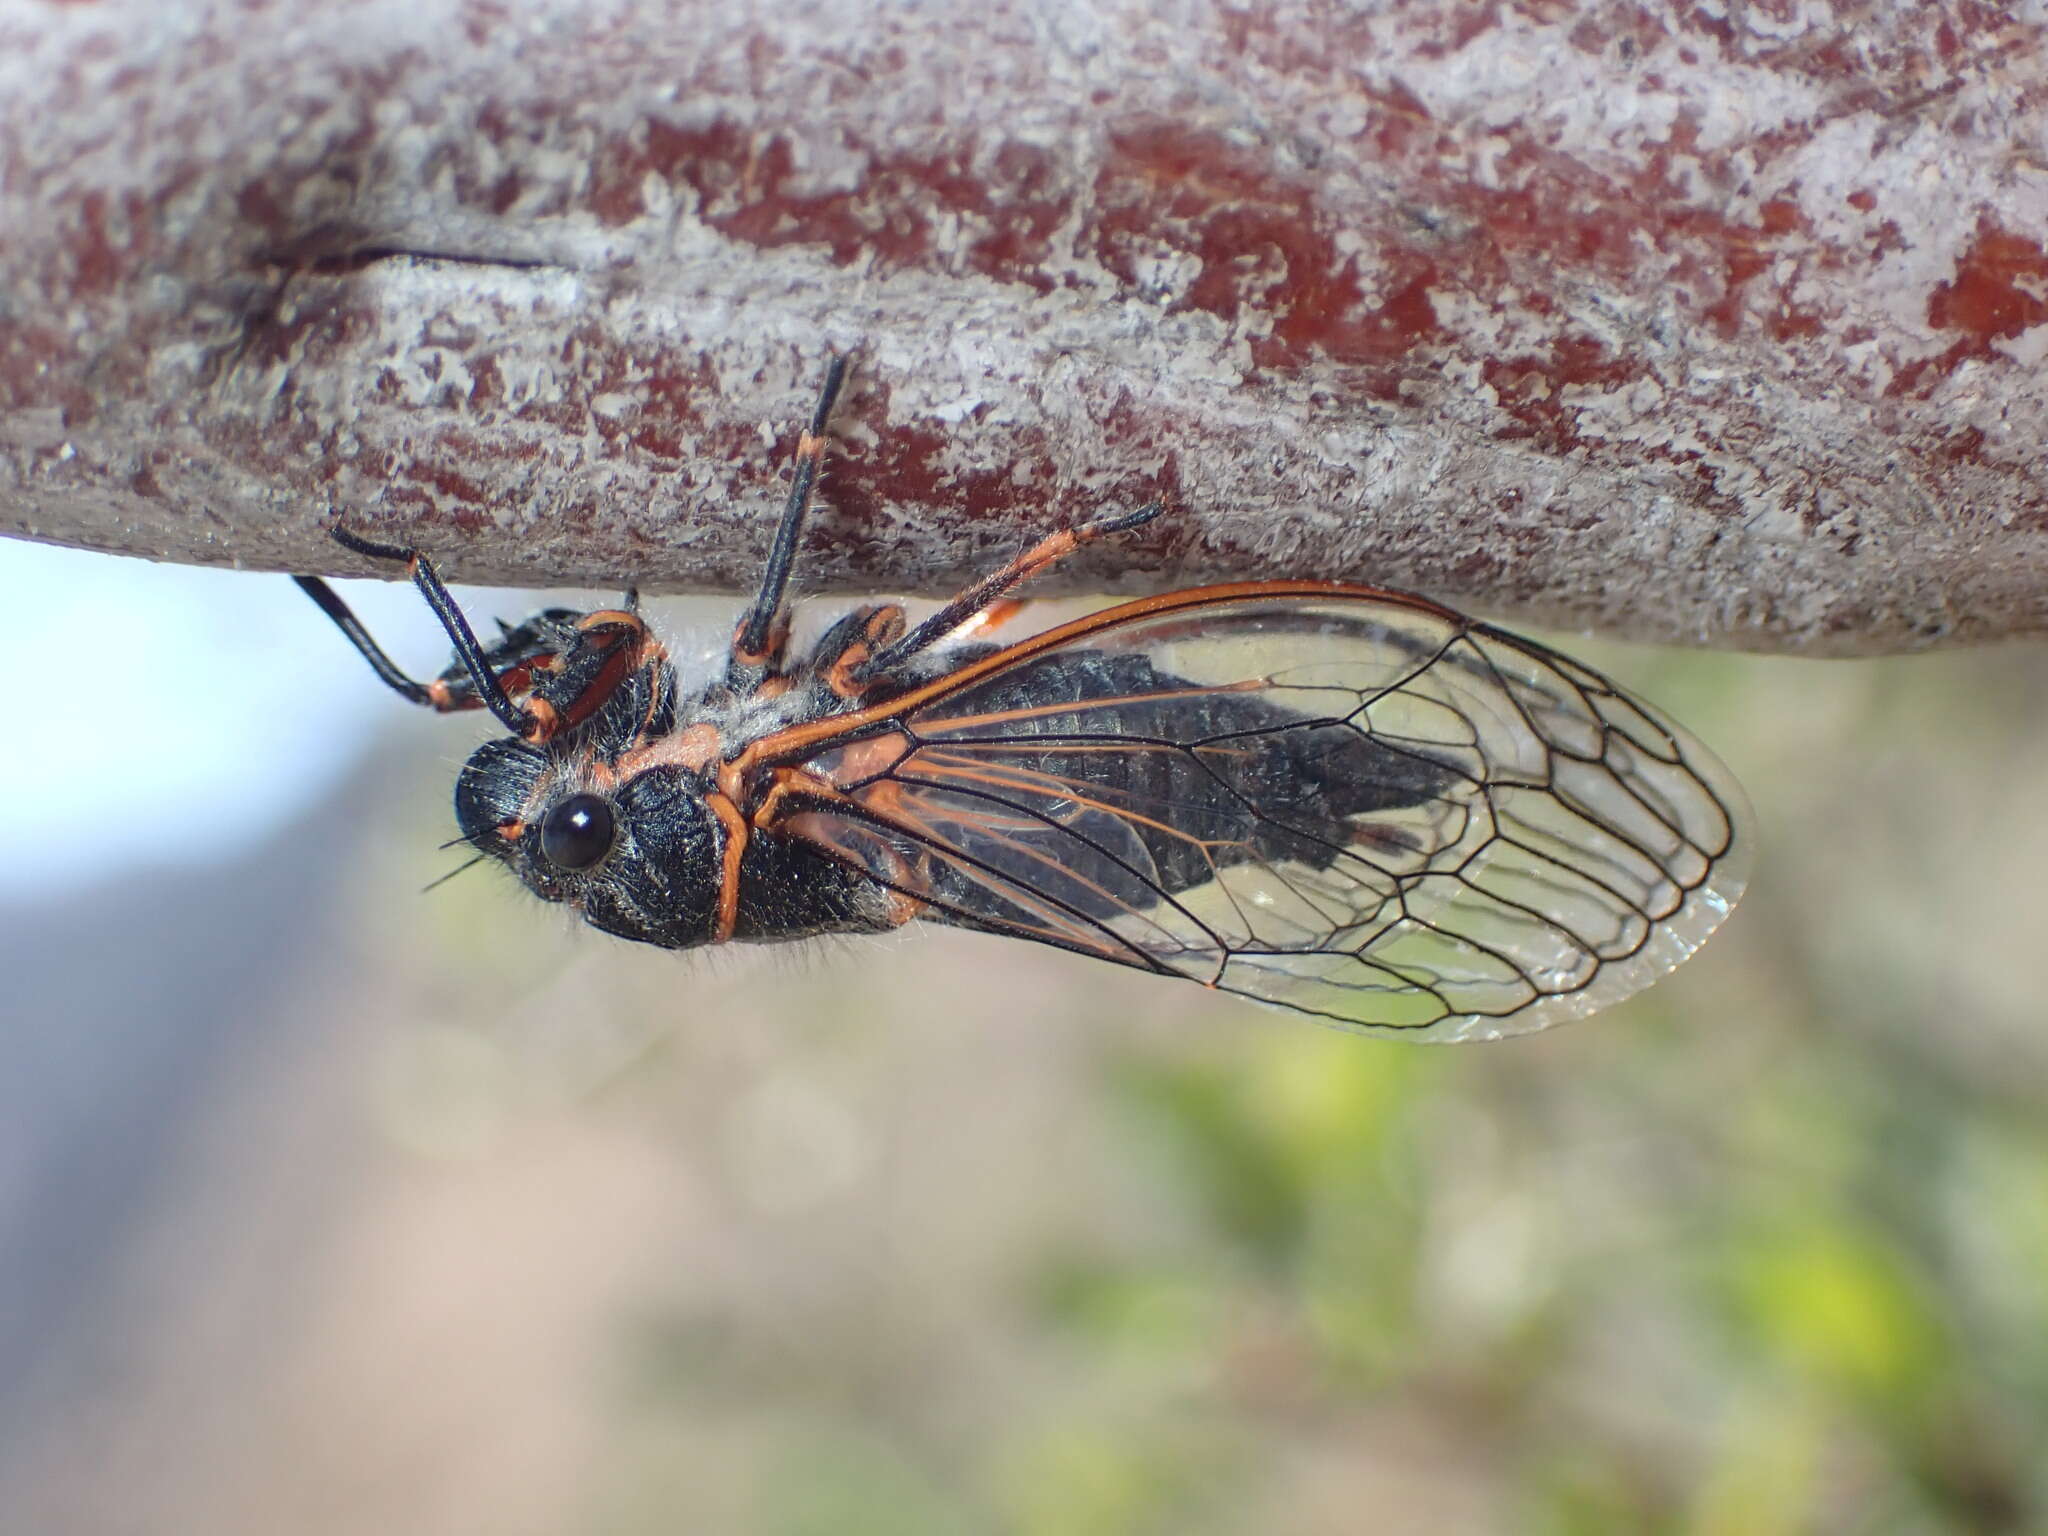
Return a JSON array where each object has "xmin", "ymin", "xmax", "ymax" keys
[{"xmin": 0, "ymin": 0, "xmax": 2048, "ymax": 651}]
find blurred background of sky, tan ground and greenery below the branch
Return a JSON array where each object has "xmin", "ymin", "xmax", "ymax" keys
[{"xmin": 0, "ymin": 541, "xmax": 2048, "ymax": 1536}]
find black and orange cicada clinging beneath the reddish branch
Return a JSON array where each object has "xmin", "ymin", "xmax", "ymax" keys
[{"xmin": 295, "ymin": 360, "xmax": 1751, "ymax": 1040}]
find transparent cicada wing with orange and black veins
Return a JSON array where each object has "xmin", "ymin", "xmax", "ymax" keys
[{"xmin": 788, "ymin": 588, "xmax": 1751, "ymax": 1040}]
